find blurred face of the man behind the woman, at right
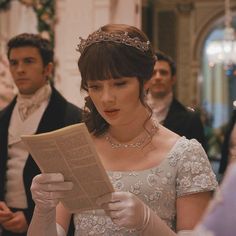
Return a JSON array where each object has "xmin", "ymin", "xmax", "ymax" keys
[{"xmin": 148, "ymin": 61, "xmax": 176, "ymax": 98}]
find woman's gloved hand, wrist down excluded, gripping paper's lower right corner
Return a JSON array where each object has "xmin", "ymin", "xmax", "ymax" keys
[{"xmin": 97, "ymin": 192, "xmax": 148, "ymax": 230}]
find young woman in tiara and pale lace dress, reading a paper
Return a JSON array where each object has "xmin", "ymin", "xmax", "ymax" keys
[{"xmin": 28, "ymin": 24, "xmax": 217, "ymax": 236}]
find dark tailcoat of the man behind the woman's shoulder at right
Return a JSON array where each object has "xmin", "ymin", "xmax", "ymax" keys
[{"xmin": 163, "ymin": 98, "xmax": 206, "ymax": 150}]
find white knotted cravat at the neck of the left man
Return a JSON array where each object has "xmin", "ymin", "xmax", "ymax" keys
[{"xmin": 17, "ymin": 84, "xmax": 51, "ymax": 120}]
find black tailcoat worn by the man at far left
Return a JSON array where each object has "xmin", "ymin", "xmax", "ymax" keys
[{"xmin": 0, "ymin": 88, "xmax": 82, "ymax": 236}]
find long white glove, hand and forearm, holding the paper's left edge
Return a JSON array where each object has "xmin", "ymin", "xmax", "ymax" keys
[{"xmin": 27, "ymin": 173, "xmax": 73, "ymax": 236}]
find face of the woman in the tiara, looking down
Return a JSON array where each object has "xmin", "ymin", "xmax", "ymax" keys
[{"xmin": 88, "ymin": 77, "xmax": 144, "ymax": 126}]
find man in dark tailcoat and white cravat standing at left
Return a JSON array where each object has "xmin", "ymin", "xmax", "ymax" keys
[{"xmin": 0, "ymin": 33, "xmax": 81, "ymax": 236}]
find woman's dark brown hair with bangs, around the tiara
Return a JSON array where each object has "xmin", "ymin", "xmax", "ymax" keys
[{"xmin": 78, "ymin": 24, "xmax": 155, "ymax": 135}]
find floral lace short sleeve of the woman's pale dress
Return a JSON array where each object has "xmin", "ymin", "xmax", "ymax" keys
[{"xmin": 176, "ymin": 139, "xmax": 218, "ymax": 197}]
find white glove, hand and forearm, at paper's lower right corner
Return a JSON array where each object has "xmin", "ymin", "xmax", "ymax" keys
[{"xmin": 97, "ymin": 192, "xmax": 176, "ymax": 236}]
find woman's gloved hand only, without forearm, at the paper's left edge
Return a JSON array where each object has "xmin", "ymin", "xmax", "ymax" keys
[{"xmin": 31, "ymin": 173, "xmax": 73, "ymax": 213}]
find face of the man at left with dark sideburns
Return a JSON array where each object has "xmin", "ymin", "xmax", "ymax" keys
[{"xmin": 9, "ymin": 46, "xmax": 52, "ymax": 95}]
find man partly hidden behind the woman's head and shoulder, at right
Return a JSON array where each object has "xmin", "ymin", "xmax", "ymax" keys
[{"xmin": 148, "ymin": 52, "xmax": 206, "ymax": 149}]
